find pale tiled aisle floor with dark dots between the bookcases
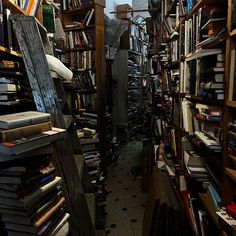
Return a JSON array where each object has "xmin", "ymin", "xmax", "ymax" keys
[{"xmin": 106, "ymin": 141, "xmax": 147, "ymax": 236}]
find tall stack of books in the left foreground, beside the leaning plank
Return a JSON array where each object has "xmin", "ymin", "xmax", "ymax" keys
[{"xmin": 0, "ymin": 112, "xmax": 70, "ymax": 236}]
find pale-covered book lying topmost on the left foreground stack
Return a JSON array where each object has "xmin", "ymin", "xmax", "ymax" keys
[{"xmin": 0, "ymin": 111, "xmax": 51, "ymax": 129}]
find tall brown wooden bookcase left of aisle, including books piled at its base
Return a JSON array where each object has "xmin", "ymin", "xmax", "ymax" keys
[{"xmin": 61, "ymin": 0, "xmax": 108, "ymax": 229}]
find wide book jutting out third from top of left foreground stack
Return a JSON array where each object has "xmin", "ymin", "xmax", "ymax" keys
[{"xmin": 0, "ymin": 127, "xmax": 66, "ymax": 155}]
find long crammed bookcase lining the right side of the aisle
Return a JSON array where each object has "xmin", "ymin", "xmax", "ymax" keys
[{"xmin": 146, "ymin": 0, "xmax": 235, "ymax": 235}]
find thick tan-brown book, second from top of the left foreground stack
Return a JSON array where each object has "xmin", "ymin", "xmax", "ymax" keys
[{"xmin": 0, "ymin": 121, "xmax": 52, "ymax": 142}]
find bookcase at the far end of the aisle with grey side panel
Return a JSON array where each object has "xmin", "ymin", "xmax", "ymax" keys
[{"xmin": 113, "ymin": 16, "xmax": 147, "ymax": 142}]
